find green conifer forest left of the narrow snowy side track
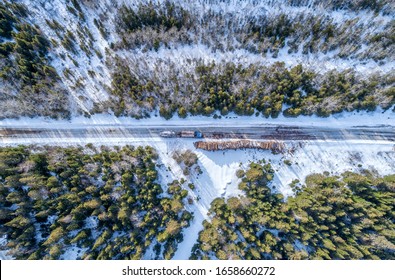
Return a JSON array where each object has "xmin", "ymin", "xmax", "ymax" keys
[{"xmin": 0, "ymin": 146, "xmax": 192, "ymax": 260}]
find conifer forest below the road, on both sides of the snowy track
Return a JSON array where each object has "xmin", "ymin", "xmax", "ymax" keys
[{"xmin": 0, "ymin": 145, "xmax": 395, "ymax": 260}]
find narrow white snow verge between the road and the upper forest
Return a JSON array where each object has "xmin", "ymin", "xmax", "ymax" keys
[{"xmin": 0, "ymin": 108, "xmax": 395, "ymax": 129}]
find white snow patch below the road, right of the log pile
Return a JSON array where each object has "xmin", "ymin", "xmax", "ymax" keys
[{"xmin": 272, "ymin": 140, "xmax": 395, "ymax": 196}]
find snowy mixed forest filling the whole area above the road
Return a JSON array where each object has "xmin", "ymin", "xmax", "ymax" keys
[{"xmin": 0, "ymin": 0, "xmax": 395, "ymax": 119}]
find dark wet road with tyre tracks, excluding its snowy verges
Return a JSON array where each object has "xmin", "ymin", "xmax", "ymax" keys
[{"xmin": 0, "ymin": 125, "xmax": 395, "ymax": 145}]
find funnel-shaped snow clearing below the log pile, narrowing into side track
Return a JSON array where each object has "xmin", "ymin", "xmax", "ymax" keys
[{"xmin": 152, "ymin": 139, "xmax": 270, "ymax": 260}]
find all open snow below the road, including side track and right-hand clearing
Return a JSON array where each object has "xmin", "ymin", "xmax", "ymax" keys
[{"xmin": 1, "ymin": 138, "xmax": 395, "ymax": 259}]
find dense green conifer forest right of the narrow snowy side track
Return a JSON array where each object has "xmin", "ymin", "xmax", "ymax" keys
[{"xmin": 191, "ymin": 163, "xmax": 395, "ymax": 260}]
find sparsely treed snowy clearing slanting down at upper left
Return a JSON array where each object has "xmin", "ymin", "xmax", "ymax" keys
[{"xmin": 20, "ymin": 0, "xmax": 115, "ymax": 114}]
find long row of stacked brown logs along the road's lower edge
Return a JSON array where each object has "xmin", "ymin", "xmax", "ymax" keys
[{"xmin": 193, "ymin": 140, "xmax": 285, "ymax": 153}]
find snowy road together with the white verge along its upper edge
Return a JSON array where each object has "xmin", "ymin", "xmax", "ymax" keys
[{"xmin": 0, "ymin": 109, "xmax": 395, "ymax": 146}]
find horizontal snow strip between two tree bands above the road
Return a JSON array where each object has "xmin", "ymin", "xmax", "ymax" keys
[{"xmin": 122, "ymin": 41, "xmax": 395, "ymax": 83}]
